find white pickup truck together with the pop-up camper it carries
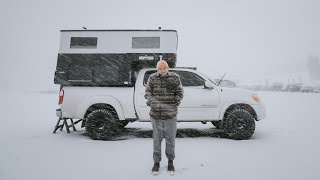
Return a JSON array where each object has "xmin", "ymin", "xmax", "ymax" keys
[{"xmin": 54, "ymin": 28, "xmax": 266, "ymax": 140}]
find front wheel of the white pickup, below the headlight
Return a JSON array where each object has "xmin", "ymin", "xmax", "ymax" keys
[{"xmin": 224, "ymin": 108, "xmax": 255, "ymax": 140}]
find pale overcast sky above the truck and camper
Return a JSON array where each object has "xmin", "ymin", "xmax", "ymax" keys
[{"xmin": 0, "ymin": 0, "xmax": 320, "ymax": 89}]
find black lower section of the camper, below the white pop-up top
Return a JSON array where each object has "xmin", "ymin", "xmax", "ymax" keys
[{"xmin": 54, "ymin": 53, "xmax": 177, "ymax": 87}]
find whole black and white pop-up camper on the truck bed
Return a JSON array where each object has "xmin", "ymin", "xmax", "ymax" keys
[{"xmin": 54, "ymin": 30, "xmax": 178, "ymax": 87}]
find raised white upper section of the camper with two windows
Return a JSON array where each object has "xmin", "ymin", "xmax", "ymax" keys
[{"xmin": 59, "ymin": 29, "xmax": 178, "ymax": 54}]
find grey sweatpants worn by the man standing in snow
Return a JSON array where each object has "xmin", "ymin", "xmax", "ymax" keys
[{"xmin": 151, "ymin": 118, "xmax": 177, "ymax": 163}]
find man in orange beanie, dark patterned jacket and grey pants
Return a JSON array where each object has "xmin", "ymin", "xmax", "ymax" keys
[{"xmin": 145, "ymin": 60, "xmax": 183, "ymax": 174}]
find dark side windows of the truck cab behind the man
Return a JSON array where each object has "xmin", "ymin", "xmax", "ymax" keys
[{"xmin": 143, "ymin": 70, "xmax": 205, "ymax": 86}]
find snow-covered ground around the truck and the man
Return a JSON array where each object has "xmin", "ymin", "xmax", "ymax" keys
[{"xmin": 0, "ymin": 92, "xmax": 320, "ymax": 180}]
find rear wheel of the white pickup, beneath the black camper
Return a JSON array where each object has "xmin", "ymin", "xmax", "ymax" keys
[{"xmin": 85, "ymin": 109, "xmax": 123, "ymax": 140}]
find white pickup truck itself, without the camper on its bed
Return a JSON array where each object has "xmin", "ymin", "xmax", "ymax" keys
[{"xmin": 57, "ymin": 68, "xmax": 266, "ymax": 140}]
